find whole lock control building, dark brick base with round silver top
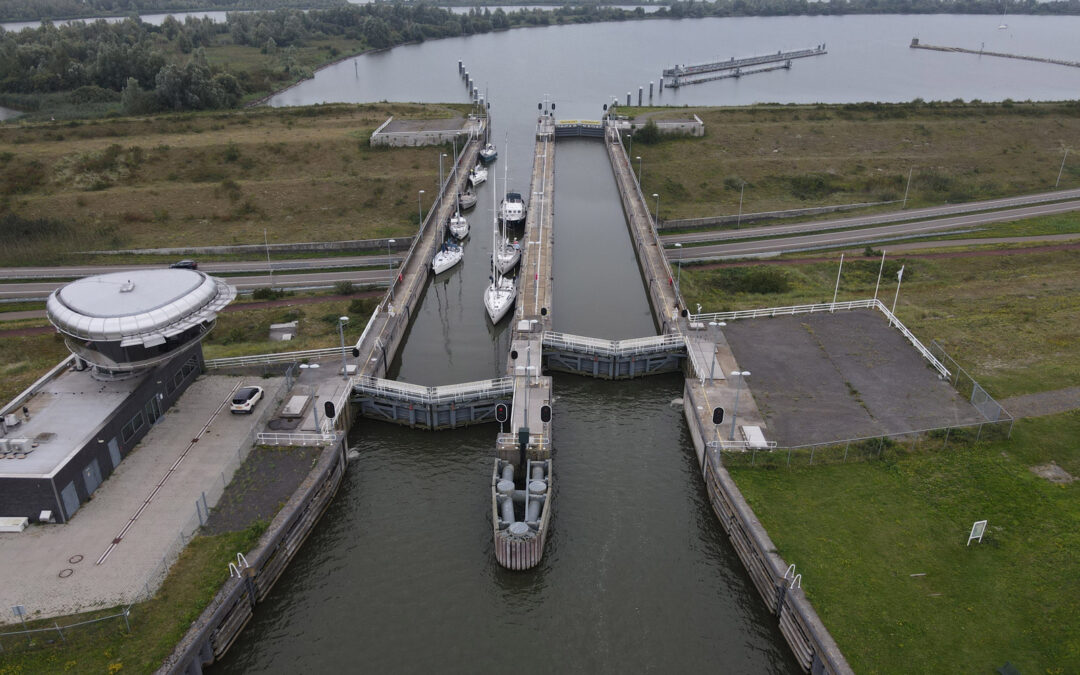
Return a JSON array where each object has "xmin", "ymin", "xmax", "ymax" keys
[{"xmin": 0, "ymin": 269, "xmax": 237, "ymax": 523}]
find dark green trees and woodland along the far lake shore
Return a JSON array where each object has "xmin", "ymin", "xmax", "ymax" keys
[{"xmin": 0, "ymin": 0, "xmax": 1080, "ymax": 113}]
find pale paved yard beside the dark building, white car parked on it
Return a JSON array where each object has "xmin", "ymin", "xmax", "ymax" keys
[{"xmin": 0, "ymin": 376, "xmax": 283, "ymax": 622}]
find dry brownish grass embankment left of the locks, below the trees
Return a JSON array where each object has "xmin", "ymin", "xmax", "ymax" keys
[{"xmin": 0, "ymin": 104, "xmax": 473, "ymax": 265}]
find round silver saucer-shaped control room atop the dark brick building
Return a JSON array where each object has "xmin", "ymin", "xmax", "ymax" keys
[{"xmin": 45, "ymin": 269, "xmax": 237, "ymax": 379}]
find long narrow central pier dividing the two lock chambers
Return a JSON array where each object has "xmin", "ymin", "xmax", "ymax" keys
[{"xmin": 491, "ymin": 111, "xmax": 555, "ymax": 570}]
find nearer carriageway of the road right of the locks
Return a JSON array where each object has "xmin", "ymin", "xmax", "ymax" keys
[{"xmin": 665, "ymin": 201, "xmax": 1080, "ymax": 260}]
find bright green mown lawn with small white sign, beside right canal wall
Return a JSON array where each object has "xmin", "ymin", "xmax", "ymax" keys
[{"xmin": 731, "ymin": 413, "xmax": 1080, "ymax": 673}]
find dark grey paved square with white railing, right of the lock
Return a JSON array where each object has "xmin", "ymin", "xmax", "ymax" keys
[{"xmin": 724, "ymin": 309, "xmax": 983, "ymax": 446}]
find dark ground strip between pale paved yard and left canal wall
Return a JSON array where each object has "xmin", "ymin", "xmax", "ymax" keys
[{"xmin": 204, "ymin": 447, "xmax": 322, "ymax": 535}]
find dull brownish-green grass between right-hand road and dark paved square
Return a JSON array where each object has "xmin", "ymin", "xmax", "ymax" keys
[{"xmin": 681, "ymin": 246, "xmax": 1080, "ymax": 399}]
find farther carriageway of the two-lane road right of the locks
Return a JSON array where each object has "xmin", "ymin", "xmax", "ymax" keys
[{"xmin": 660, "ymin": 189, "xmax": 1080, "ymax": 246}]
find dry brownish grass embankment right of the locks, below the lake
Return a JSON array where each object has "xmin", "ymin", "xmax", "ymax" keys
[{"xmin": 621, "ymin": 103, "xmax": 1080, "ymax": 219}]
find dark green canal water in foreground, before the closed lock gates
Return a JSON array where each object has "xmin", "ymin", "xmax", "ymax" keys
[{"xmin": 213, "ymin": 376, "xmax": 798, "ymax": 673}]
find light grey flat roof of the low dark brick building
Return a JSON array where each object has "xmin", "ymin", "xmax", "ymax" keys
[{"xmin": 0, "ymin": 362, "xmax": 149, "ymax": 478}]
